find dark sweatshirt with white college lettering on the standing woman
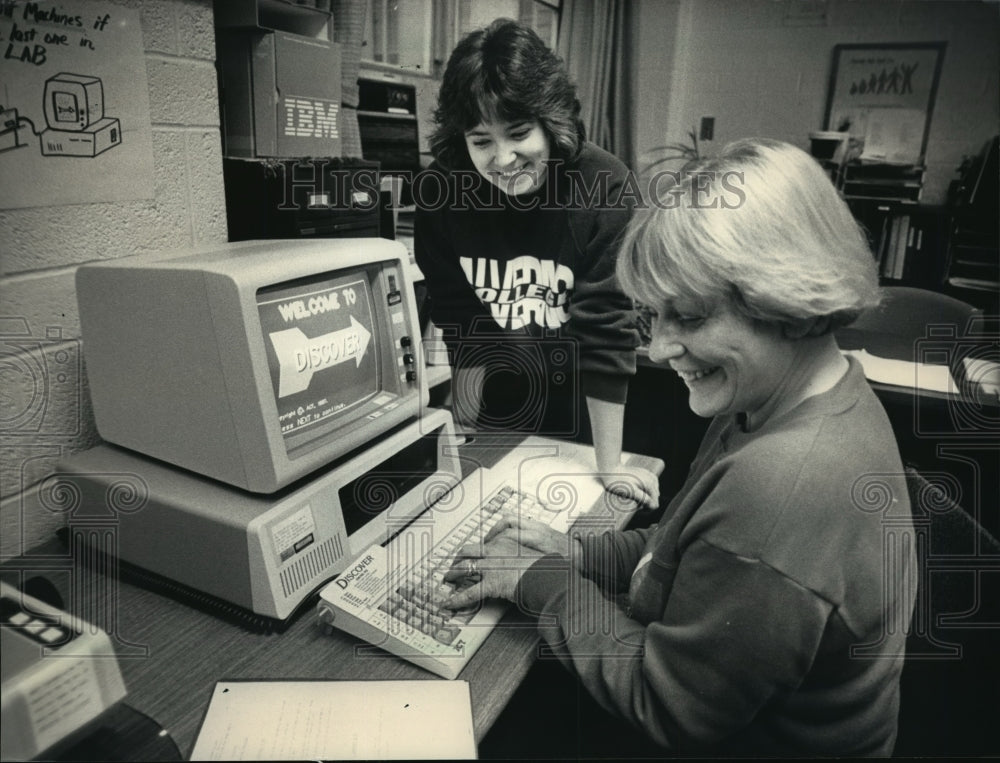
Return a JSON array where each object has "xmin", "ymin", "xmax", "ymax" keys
[{"xmin": 414, "ymin": 143, "xmax": 638, "ymax": 434}]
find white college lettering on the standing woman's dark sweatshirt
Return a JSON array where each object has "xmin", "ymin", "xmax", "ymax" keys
[{"xmin": 460, "ymin": 255, "xmax": 573, "ymax": 329}]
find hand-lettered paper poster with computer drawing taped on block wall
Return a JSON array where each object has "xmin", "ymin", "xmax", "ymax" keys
[{"xmin": 0, "ymin": 0, "xmax": 153, "ymax": 209}]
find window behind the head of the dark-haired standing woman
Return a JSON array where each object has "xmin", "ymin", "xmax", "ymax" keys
[{"xmin": 361, "ymin": 0, "xmax": 561, "ymax": 76}]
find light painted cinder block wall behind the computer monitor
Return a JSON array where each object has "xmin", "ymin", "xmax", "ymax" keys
[{"xmin": 0, "ymin": 0, "xmax": 227, "ymax": 557}]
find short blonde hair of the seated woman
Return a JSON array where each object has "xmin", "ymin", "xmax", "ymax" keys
[{"xmin": 618, "ymin": 139, "xmax": 880, "ymax": 330}]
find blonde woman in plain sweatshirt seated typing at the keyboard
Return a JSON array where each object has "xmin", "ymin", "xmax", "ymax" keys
[{"xmin": 451, "ymin": 141, "xmax": 915, "ymax": 756}]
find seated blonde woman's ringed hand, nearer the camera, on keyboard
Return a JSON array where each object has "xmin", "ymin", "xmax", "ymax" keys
[{"xmin": 443, "ymin": 530, "xmax": 544, "ymax": 610}]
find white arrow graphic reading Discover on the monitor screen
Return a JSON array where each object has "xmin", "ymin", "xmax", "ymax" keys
[{"xmin": 271, "ymin": 315, "xmax": 372, "ymax": 397}]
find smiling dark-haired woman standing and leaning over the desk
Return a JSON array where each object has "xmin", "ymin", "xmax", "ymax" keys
[{"xmin": 414, "ymin": 19, "xmax": 659, "ymax": 506}]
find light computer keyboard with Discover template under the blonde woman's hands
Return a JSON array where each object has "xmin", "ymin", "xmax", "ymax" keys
[{"xmin": 317, "ymin": 469, "xmax": 571, "ymax": 678}]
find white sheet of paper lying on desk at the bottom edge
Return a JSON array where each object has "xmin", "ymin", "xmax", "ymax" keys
[{"xmin": 191, "ymin": 681, "xmax": 476, "ymax": 760}]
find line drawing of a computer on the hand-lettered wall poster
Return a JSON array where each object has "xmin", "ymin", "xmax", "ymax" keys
[{"xmin": 41, "ymin": 72, "xmax": 122, "ymax": 157}]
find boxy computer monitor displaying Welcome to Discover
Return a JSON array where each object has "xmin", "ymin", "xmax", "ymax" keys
[{"xmin": 76, "ymin": 238, "xmax": 428, "ymax": 494}]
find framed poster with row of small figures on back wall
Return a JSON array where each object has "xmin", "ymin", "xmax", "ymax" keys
[{"xmin": 826, "ymin": 42, "xmax": 947, "ymax": 164}]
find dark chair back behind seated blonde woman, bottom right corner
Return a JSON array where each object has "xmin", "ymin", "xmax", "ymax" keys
[{"xmin": 893, "ymin": 467, "xmax": 1000, "ymax": 757}]
